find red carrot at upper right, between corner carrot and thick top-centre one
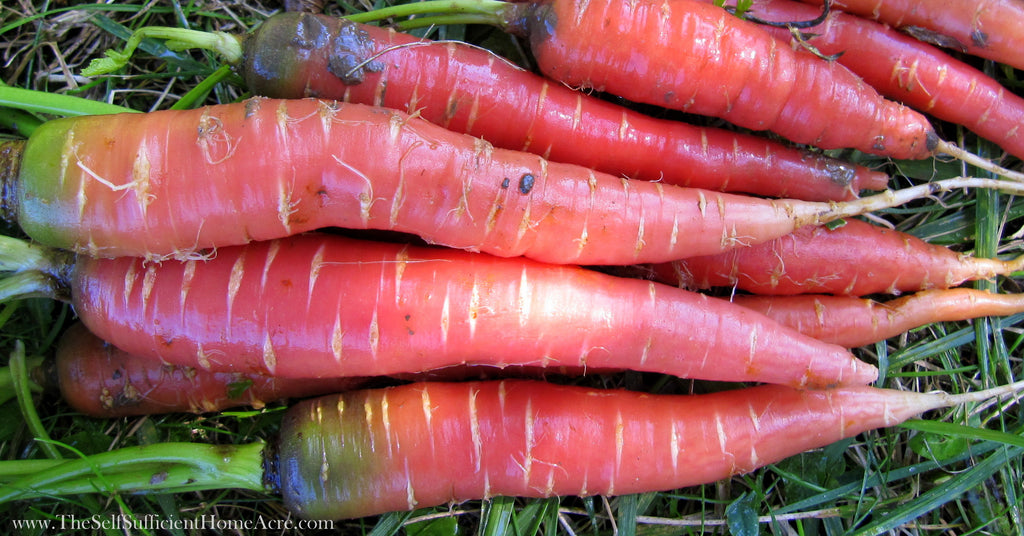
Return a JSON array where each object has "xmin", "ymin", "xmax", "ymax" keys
[{"xmin": 752, "ymin": 0, "xmax": 1024, "ymax": 158}]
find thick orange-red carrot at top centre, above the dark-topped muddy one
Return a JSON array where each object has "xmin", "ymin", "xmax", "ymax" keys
[{"xmin": 517, "ymin": 0, "xmax": 938, "ymax": 159}]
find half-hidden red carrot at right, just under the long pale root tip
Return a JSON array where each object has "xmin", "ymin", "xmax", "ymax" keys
[{"xmin": 654, "ymin": 219, "xmax": 1024, "ymax": 296}]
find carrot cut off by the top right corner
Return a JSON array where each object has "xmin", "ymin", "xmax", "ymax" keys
[{"xmin": 803, "ymin": 0, "xmax": 1024, "ymax": 69}]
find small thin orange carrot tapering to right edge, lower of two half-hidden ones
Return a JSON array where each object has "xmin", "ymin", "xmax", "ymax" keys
[{"xmin": 732, "ymin": 288, "xmax": 1024, "ymax": 348}]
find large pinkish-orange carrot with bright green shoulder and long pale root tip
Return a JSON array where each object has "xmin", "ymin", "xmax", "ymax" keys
[{"xmin": 0, "ymin": 98, "xmax": 1024, "ymax": 264}]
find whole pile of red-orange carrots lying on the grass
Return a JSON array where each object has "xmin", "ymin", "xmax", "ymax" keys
[{"xmin": 0, "ymin": 0, "xmax": 1024, "ymax": 519}]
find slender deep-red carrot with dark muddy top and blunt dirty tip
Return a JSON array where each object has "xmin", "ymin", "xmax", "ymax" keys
[{"xmin": 240, "ymin": 13, "xmax": 888, "ymax": 201}]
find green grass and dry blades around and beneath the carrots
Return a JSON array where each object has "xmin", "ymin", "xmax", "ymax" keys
[{"xmin": 0, "ymin": 0, "xmax": 1024, "ymax": 536}]
